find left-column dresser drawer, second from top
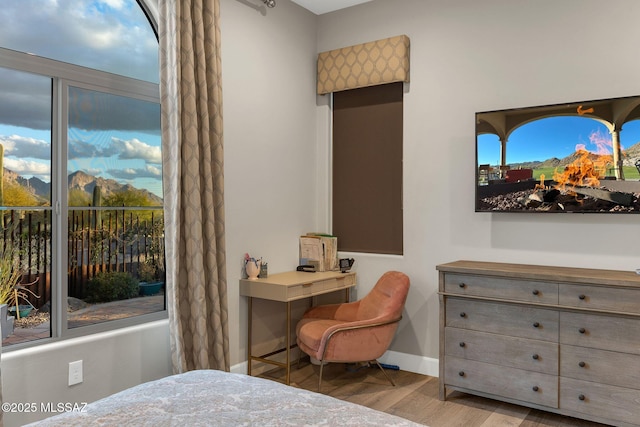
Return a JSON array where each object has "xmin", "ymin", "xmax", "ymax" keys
[{"xmin": 445, "ymin": 297, "xmax": 559, "ymax": 342}]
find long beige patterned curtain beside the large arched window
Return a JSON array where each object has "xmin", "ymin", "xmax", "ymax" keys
[{"xmin": 158, "ymin": 0, "xmax": 229, "ymax": 373}]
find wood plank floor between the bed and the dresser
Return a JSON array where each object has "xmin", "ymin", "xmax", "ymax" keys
[{"xmin": 262, "ymin": 361, "xmax": 604, "ymax": 427}]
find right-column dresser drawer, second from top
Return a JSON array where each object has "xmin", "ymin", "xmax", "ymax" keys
[{"xmin": 560, "ymin": 312, "xmax": 640, "ymax": 354}]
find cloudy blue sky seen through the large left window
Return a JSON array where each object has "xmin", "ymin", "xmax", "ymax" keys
[{"xmin": 0, "ymin": 0, "xmax": 162, "ymax": 200}]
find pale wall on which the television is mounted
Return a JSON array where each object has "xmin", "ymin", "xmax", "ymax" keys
[{"xmin": 318, "ymin": 0, "xmax": 640, "ymax": 371}]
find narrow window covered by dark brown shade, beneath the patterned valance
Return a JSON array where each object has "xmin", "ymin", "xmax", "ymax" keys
[{"xmin": 333, "ymin": 83, "xmax": 403, "ymax": 255}]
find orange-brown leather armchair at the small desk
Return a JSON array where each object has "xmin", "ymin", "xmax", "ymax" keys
[{"xmin": 296, "ymin": 271, "xmax": 409, "ymax": 391}]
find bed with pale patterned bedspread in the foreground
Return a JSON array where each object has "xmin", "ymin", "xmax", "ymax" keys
[{"xmin": 29, "ymin": 370, "xmax": 419, "ymax": 427}]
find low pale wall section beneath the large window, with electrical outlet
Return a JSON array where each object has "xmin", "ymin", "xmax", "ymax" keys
[{"xmin": 2, "ymin": 320, "xmax": 171, "ymax": 427}]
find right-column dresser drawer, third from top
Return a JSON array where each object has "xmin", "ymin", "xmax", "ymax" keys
[{"xmin": 560, "ymin": 345, "xmax": 640, "ymax": 389}]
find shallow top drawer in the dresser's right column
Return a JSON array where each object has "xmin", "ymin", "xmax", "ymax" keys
[{"xmin": 559, "ymin": 284, "xmax": 640, "ymax": 314}]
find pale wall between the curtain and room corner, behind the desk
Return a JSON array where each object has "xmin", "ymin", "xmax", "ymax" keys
[{"xmin": 221, "ymin": 0, "xmax": 324, "ymax": 372}]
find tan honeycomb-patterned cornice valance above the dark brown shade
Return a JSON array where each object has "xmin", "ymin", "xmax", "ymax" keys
[{"xmin": 318, "ymin": 35, "xmax": 409, "ymax": 95}]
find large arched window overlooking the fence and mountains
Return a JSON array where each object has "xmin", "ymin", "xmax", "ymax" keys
[{"xmin": 0, "ymin": 0, "xmax": 166, "ymax": 349}]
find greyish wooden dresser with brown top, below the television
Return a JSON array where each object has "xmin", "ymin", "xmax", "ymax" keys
[{"xmin": 436, "ymin": 261, "xmax": 640, "ymax": 426}]
